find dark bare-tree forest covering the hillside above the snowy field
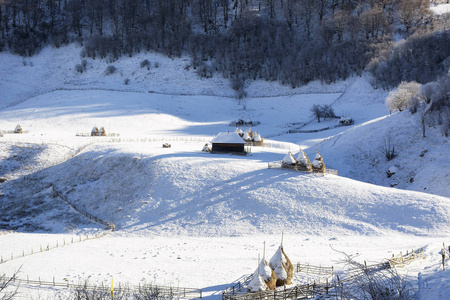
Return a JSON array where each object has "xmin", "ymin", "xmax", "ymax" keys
[{"xmin": 0, "ymin": 0, "xmax": 450, "ymax": 92}]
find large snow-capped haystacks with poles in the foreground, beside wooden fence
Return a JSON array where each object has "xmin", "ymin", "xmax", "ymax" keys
[{"xmin": 247, "ymin": 246, "xmax": 294, "ymax": 292}]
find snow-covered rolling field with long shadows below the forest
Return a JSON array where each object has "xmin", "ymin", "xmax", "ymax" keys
[{"xmin": 0, "ymin": 45, "xmax": 450, "ymax": 299}]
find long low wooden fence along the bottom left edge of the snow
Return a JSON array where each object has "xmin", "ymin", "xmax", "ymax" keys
[{"xmin": 4, "ymin": 276, "xmax": 203, "ymax": 299}]
